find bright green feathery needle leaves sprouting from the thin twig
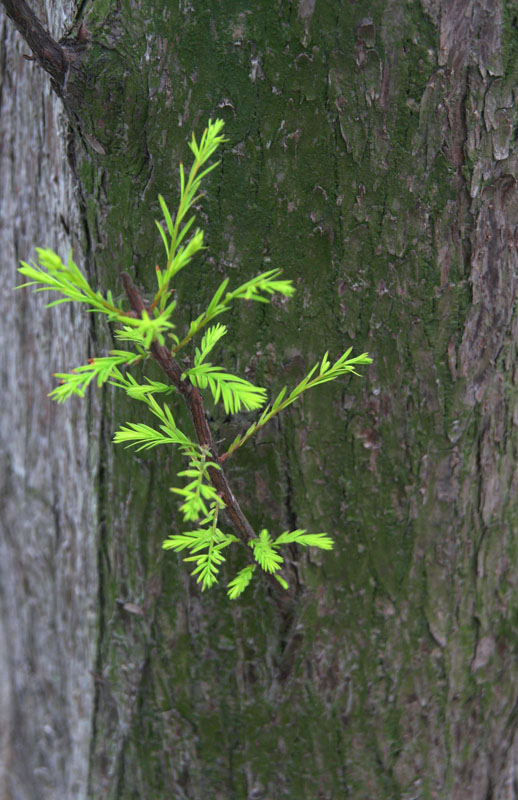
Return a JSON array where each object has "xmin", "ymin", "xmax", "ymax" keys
[{"xmin": 18, "ymin": 120, "xmax": 371, "ymax": 600}]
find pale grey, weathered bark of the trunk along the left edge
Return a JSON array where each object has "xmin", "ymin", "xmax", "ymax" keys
[{"xmin": 0, "ymin": 0, "xmax": 98, "ymax": 800}]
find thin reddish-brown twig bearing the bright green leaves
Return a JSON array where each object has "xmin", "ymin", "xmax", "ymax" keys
[{"xmin": 121, "ymin": 272, "xmax": 255, "ymax": 543}]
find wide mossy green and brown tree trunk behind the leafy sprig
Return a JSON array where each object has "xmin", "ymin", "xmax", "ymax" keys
[{"xmin": 0, "ymin": 0, "xmax": 518, "ymax": 800}]
